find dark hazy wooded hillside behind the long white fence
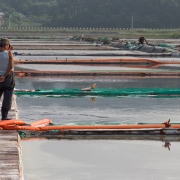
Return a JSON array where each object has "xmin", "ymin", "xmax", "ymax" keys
[{"xmin": 0, "ymin": 0, "xmax": 180, "ymax": 28}]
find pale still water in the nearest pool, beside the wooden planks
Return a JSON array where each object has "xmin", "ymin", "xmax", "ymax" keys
[{"xmin": 21, "ymin": 140, "xmax": 180, "ymax": 180}]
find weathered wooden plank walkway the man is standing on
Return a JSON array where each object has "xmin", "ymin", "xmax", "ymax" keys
[{"xmin": 0, "ymin": 95, "xmax": 24, "ymax": 180}]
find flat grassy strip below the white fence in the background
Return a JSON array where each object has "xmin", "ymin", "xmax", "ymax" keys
[{"xmin": 0, "ymin": 27, "xmax": 180, "ymax": 39}]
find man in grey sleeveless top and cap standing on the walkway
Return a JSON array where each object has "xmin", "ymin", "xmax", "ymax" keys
[{"xmin": 0, "ymin": 38, "xmax": 15, "ymax": 120}]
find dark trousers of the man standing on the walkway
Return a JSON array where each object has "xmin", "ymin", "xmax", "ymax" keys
[{"xmin": 0, "ymin": 71, "xmax": 15, "ymax": 119}]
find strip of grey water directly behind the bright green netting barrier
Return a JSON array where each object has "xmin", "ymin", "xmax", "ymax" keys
[{"xmin": 16, "ymin": 76, "xmax": 180, "ymax": 89}]
